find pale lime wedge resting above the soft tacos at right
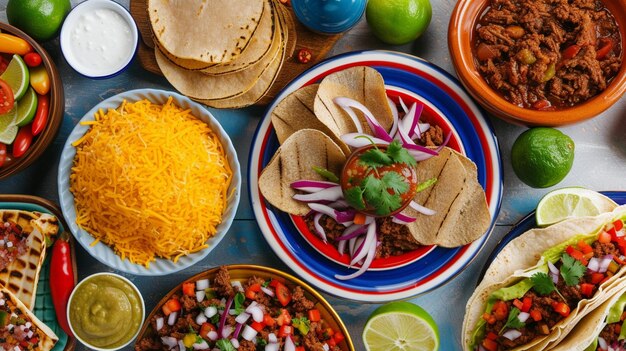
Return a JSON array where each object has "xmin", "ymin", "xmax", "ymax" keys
[{"xmin": 535, "ymin": 187, "xmax": 617, "ymax": 227}]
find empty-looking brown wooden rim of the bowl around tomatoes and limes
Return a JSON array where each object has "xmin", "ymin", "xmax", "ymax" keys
[{"xmin": 0, "ymin": 22, "xmax": 65, "ymax": 179}]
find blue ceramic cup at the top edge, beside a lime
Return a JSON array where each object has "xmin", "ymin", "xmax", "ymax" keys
[{"xmin": 291, "ymin": 0, "xmax": 367, "ymax": 34}]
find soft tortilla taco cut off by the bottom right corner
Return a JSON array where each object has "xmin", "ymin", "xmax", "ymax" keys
[{"xmin": 550, "ymin": 284, "xmax": 626, "ymax": 351}]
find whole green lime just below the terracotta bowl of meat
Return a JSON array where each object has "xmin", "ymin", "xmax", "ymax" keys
[{"xmin": 511, "ymin": 127, "xmax": 574, "ymax": 188}]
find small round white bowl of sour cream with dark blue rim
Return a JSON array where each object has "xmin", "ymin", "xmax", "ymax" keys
[{"xmin": 60, "ymin": 0, "xmax": 139, "ymax": 78}]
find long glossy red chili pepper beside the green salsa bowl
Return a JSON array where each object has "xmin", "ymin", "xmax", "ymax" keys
[{"xmin": 50, "ymin": 232, "xmax": 75, "ymax": 337}]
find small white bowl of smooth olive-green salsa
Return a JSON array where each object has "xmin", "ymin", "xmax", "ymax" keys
[{"xmin": 67, "ymin": 273, "xmax": 146, "ymax": 351}]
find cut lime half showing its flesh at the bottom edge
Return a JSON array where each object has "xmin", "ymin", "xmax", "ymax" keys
[{"xmin": 363, "ymin": 301, "xmax": 439, "ymax": 351}]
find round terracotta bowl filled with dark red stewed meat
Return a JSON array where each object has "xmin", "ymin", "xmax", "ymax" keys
[{"xmin": 448, "ymin": 0, "xmax": 626, "ymax": 126}]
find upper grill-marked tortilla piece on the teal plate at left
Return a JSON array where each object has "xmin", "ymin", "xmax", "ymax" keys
[{"xmin": 0, "ymin": 210, "xmax": 59, "ymax": 309}]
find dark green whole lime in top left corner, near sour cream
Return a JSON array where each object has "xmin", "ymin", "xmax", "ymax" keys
[{"xmin": 7, "ymin": 0, "xmax": 71, "ymax": 41}]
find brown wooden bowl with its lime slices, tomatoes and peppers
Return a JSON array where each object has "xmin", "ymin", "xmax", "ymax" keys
[{"xmin": 0, "ymin": 22, "xmax": 65, "ymax": 179}]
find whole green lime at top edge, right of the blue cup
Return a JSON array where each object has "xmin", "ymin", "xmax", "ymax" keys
[{"xmin": 365, "ymin": 0, "xmax": 432, "ymax": 45}]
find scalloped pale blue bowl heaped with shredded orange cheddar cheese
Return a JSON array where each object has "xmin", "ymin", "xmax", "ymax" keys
[{"xmin": 58, "ymin": 89, "xmax": 241, "ymax": 275}]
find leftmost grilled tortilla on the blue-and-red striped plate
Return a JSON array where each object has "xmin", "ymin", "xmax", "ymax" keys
[{"xmin": 259, "ymin": 129, "xmax": 346, "ymax": 216}]
